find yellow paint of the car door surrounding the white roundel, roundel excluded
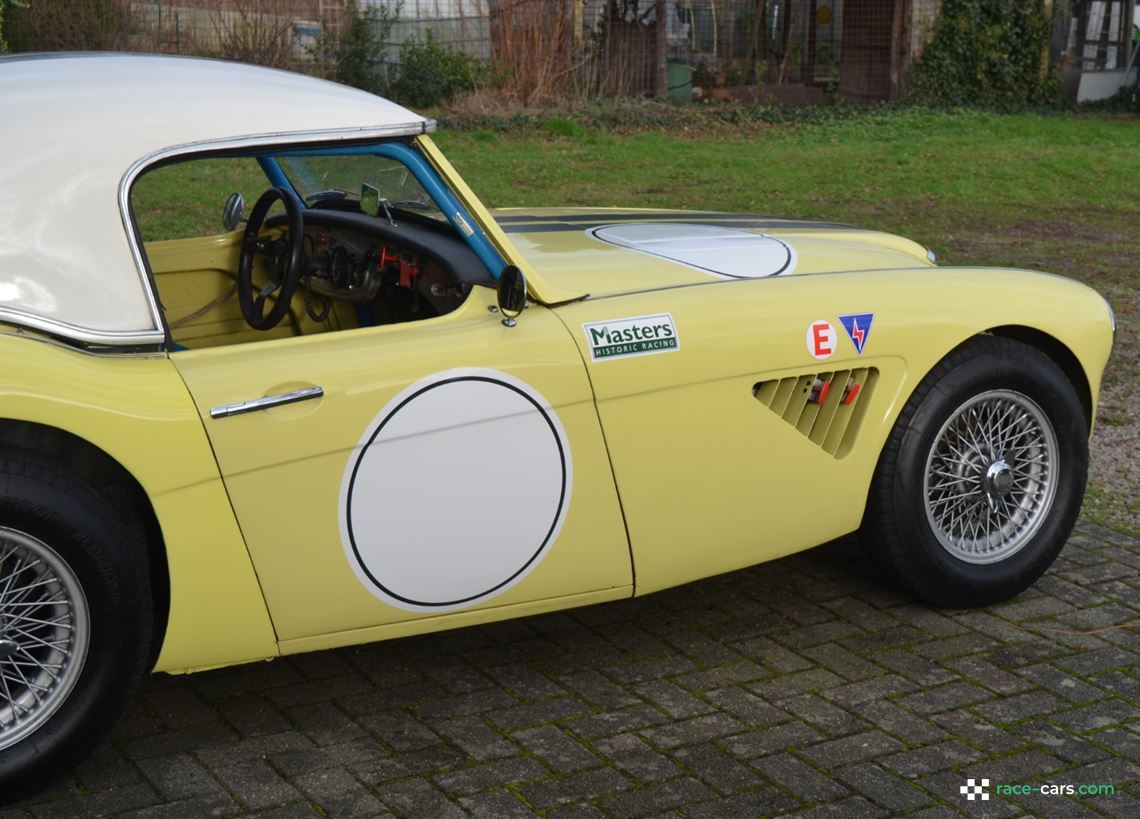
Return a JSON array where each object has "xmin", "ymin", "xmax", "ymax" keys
[{"xmin": 172, "ymin": 287, "xmax": 633, "ymax": 651}]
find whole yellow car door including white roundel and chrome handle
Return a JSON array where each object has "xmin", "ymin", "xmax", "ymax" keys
[{"xmin": 171, "ymin": 286, "xmax": 632, "ymax": 651}]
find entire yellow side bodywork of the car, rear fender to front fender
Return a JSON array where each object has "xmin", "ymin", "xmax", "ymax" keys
[{"xmin": 0, "ymin": 153, "xmax": 1112, "ymax": 671}]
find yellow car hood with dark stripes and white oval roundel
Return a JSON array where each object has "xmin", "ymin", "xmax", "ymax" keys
[{"xmin": 491, "ymin": 208, "xmax": 933, "ymax": 297}]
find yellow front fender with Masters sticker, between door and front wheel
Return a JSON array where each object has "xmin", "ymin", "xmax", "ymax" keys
[{"xmin": 547, "ymin": 269, "xmax": 1112, "ymax": 594}]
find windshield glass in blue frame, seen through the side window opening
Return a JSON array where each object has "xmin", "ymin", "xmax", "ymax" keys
[{"xmin": 274, "ymin": 154, "xmax": 447, "ymax": 221}]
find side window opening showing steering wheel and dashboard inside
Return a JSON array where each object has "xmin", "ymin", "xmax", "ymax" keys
[{"xmin": 130, "ymin": 147, "xmax": 481, "ymax": 351}]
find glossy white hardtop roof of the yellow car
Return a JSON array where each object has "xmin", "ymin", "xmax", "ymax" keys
[{"xmin": 0, "ymin": 54, "xmax": 433, "ymax": 344}]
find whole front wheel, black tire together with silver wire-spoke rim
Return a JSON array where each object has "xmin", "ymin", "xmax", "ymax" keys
[{"xmin": 861, "ymin": 336, "xmax": 1089, "ymax": 608}]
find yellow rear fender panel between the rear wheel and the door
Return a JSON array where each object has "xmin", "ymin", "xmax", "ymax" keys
[{"xmin": 0, "ymin": 331, "xmax": 277, "ymax": 671}]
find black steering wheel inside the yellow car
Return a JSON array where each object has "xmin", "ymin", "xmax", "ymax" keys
[{"xmin": 237, "ymin": 187, "xmax": 304, "ymax": 330}]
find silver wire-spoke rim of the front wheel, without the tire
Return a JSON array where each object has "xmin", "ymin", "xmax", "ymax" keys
[{"xmin": 923, "ymin": 390, "xmax": 1060, "ymax": 563}]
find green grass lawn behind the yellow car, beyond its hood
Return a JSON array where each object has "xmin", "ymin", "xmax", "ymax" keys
[{"xmin": 435, "ymin": 111, "xmax": 1140, "ymax": 535}]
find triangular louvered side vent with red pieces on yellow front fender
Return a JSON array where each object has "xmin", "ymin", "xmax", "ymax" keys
[{"xmin": 752, "ymin": 367, "xmax": 879, "ymax": 457}]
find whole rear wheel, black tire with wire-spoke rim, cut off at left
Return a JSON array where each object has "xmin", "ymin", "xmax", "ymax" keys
[{"xmin": 0, "ymin": 455, "xmax": 153, "ymax": 804}]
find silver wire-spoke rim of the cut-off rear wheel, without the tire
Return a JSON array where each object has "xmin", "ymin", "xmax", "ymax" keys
[{"xmin": 0, "ymin": 526, "xmax": 90, "ymax": 751}]
